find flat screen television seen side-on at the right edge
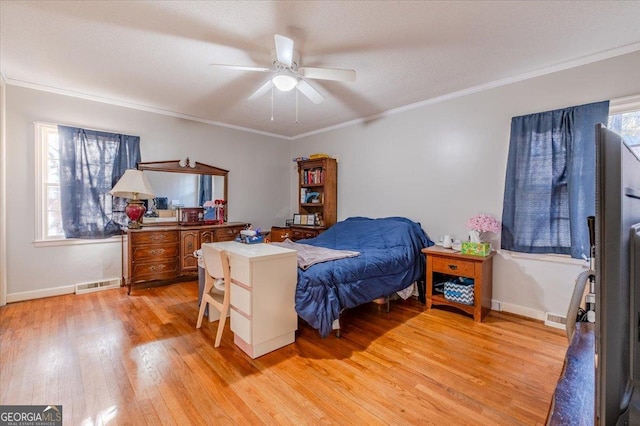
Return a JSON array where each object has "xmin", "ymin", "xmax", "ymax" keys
[{"xmin": 595, "ymin": 124, "xmax": 640, "ymax": 425}]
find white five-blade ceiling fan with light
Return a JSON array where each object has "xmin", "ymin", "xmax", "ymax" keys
[{"xmin": 211, "ymin": 34, "xmax": 356, "ymax": 104}]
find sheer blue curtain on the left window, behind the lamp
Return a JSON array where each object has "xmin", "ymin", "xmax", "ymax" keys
[{"xmin": 58, "ymin": 126, "xmax": 141, "ymax": 239}]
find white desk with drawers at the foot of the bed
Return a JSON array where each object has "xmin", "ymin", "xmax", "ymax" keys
[{"xmin": 203, "ymin": 241, "xmax": 298, "ymax": 358}]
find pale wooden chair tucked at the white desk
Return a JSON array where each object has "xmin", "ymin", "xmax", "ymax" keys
[{"xmin": 196, "ymin": 244, "xmax": 231, "ymax": 348}]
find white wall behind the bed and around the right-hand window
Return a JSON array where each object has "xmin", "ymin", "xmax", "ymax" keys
[{"xmin": 290, "ymin": 52, "xmax": 640, "ymax": 318}]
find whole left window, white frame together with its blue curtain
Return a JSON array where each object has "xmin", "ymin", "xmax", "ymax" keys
[{"xmin": 35, "ymin": 123, "xmax": 141, "ymax": 242}]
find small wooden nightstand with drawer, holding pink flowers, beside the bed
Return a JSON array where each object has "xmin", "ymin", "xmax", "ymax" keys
[{"xmin": 422, "ymin": 246, "xmax": 495, "ymax": 322}]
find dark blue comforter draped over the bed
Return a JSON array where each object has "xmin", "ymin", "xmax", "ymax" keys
[{"xmin": 296, "ymin": 217, "xmax": 433, "ymax": 337}]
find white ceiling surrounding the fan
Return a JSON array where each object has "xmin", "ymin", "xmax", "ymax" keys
[{"xmin": 0, "ymin": 0, "xmax": 640, "ymax": 138}]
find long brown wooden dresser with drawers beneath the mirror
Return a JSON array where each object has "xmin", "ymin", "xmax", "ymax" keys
[{"xmin": 123, "ymin": 222, "xmax": 248, "ymax": 294}]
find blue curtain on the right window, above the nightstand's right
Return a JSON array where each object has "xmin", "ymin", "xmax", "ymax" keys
[{"xmin": 502, "ymin": 101, "xmax": 609, "ymax": 258}]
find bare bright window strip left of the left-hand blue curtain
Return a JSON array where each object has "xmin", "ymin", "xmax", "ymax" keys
[{"xmin": 35, "ymin": 123, "xmax": 64, "ymax": 240}]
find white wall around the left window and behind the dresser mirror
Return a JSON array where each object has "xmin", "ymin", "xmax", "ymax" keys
[{"xmin": 3, "ymin": 86, "xmax": 292, "ymax": 302}]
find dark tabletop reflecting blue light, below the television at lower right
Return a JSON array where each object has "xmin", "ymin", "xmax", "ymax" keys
[{"xmin": 547, "ymin": 322, "xmax": 596, "ymax": 425}]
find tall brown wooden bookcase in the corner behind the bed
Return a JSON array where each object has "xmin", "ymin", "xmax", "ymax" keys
[{"xmin": 298, "ymin": 158, "xmax": 338, "ymax": 235}]
